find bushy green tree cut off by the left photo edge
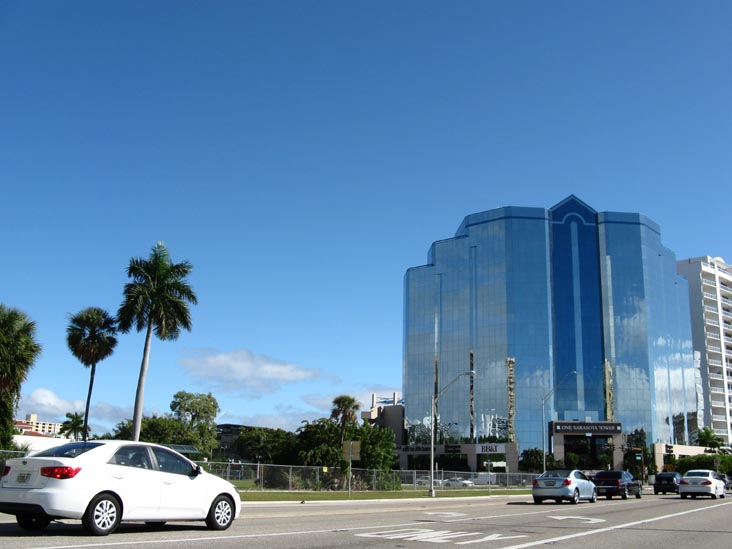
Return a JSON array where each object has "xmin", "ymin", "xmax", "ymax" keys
[{"xmin": 0, "ymin": 303, "xmax": 41, "ymax": 448}]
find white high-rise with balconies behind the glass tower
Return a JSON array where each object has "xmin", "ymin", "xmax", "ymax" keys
[{"xmin": 677, "ymin": 256, "xmax": 732, "ymax": 443}]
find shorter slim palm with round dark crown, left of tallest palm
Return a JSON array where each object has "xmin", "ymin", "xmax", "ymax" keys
[{"xmin": 66, "ymin": 307, "xmax": 117, "ymax": 442}]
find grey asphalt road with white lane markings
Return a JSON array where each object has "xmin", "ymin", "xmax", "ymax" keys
[{"xmin": 0, "ymin": 495, "xmax": 732, "ymax": 549}]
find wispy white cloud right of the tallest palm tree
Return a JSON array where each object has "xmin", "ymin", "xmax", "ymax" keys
[{"xmin": 179, "ymin": 349, "xmax": 321, "ymax": 398}]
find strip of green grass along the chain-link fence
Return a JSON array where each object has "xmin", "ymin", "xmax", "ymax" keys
[{"xmin": 241, "ymin": 488, "xmax": 531, "ymax": 501}]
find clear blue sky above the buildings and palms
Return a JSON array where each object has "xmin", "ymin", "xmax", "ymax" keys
[{"xmin": 0, "ymin": 0, "xmax": 732, "ymax": 433}]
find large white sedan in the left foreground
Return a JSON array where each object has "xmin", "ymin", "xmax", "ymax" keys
[{"xmin": 0, "ymin": 440, "xmax": 241, "ymax": 536}]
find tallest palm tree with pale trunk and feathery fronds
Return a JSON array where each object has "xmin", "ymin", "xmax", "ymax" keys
[{"xmin": 117, "ymin": 242, "xmax": 198, "ymax": 440}]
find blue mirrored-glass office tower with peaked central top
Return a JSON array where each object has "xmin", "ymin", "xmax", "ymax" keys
[{"xmin": 403, "ymin": 196, "xmax": 697, "ymax": 450}]
